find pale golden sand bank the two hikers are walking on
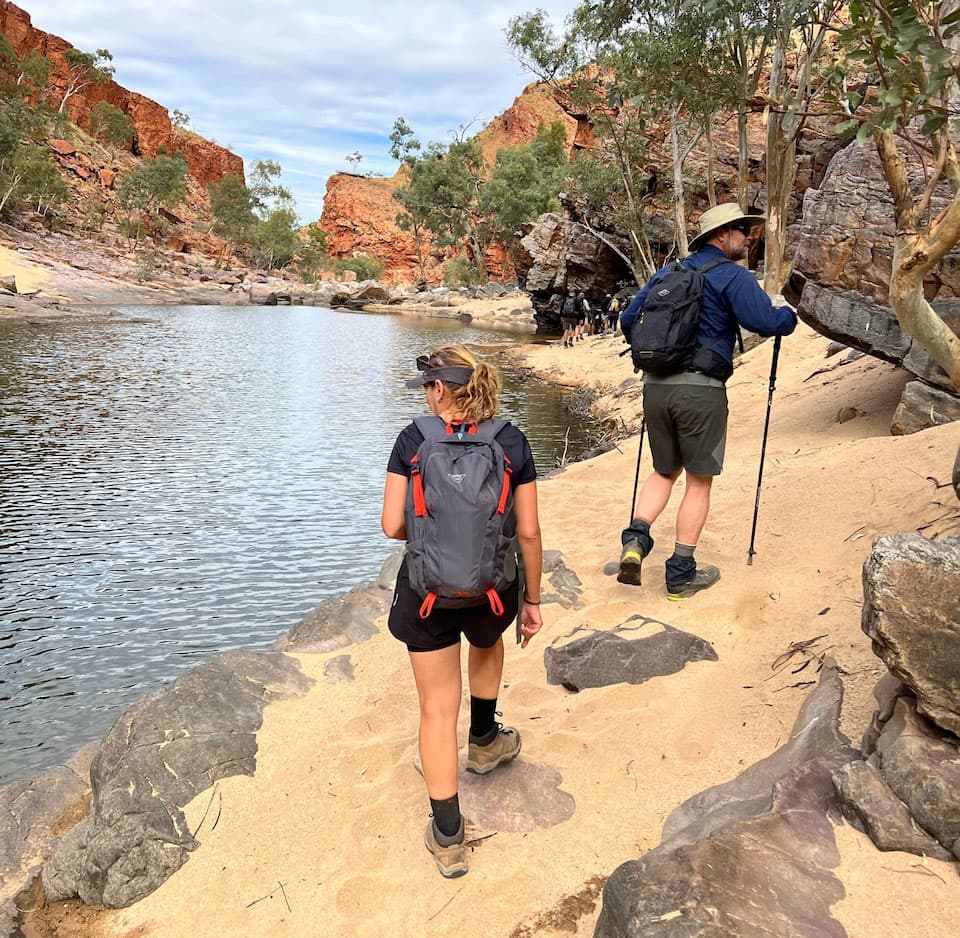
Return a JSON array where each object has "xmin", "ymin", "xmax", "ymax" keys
[{"xmin": 64, "ymin": 318, "xmax": 960, "ymax": 938}]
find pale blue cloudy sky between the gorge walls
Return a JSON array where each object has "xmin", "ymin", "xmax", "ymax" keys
[{"xmin": 18, "ymin": 0, "xmax": 576, "ymax": 223}]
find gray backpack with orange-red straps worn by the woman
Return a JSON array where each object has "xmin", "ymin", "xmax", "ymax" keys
[{"xmin": 404, "ymin": 417, "xmax": 517, "ymax": 619}]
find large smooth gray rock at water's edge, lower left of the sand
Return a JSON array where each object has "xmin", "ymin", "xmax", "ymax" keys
[{"xmin": 43, "ymin": 651, "xmax": 312, "ymax": 908}]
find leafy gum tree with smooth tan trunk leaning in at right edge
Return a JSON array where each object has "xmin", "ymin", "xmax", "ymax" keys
[{"xmin": 842, "ymin": 0, "xmax": 960, "ymax": 390}]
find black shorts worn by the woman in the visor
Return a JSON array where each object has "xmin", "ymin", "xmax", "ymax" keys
[{"xmin": 387, "ymin": 562, "xmax": 519, "ymax": 651}]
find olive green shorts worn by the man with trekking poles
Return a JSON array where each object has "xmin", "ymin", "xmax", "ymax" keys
[{"xmin": 643, "ymin": 375, "xmax": 727, "ymax": 476}]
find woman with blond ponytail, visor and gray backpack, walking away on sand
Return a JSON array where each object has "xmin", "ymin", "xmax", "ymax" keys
[{"xmin": 382, "ymin": 346, "xmax": 543, "ymax": 878}]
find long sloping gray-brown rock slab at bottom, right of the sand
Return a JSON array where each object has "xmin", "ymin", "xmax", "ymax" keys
[{"xmin": 595, "ymin": 662, "xmax": 857, "ymax": 938}]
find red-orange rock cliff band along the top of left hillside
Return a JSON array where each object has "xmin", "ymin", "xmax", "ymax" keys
[{"xmin": 0, "ymin": 0, "xmax": 243, "ymax": 186}]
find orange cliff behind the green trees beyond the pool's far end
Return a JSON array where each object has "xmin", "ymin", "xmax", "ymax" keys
[{"xmin": 320, "ymin": 84, "xmax": 576, "ymax": 283}]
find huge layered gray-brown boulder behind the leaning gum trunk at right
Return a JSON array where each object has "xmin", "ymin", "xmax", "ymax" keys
[{"xmin": 784, "ymin": 137, "xmax": 960, "ymax": 434}]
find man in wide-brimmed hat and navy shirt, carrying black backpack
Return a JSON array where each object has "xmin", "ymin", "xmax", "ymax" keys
[{"xmin": 617, "ymin": 202, "xmax": 797, "ymax": 599}]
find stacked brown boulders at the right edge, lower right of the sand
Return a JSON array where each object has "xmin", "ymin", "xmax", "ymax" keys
[{"xmin": 834, "ymin": 532, "xmax": 960, "ymax": 859}]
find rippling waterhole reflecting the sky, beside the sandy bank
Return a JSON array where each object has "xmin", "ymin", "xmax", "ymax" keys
[{"xmin": 0, "ymin": 307, "xmax": 582, "ymax": 783}]
